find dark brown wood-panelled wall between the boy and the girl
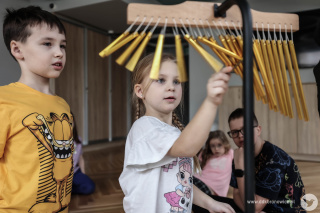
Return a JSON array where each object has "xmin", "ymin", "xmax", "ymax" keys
[{"xmin": 52, "ymin": 22, "xmax": 130, "ymax": 144}]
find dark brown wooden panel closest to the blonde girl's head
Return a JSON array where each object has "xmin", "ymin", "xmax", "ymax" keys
[{"xmin": 111, "ymin": 48, "xmax": 131, "ymax": 138}]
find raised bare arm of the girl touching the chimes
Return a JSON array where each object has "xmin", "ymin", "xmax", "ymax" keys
[{"xmin": 168, "ymin": 67, "xmax": 232, "ymax": 157}]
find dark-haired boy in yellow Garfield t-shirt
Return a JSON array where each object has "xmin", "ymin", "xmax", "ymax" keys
[{"xmin": 0, "ymin": 6, "xmax": 73, "ymax": 213}]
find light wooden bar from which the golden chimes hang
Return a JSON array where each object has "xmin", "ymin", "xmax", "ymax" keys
[{"xmin": 127, "ymin": 1, "xmax": 299, "ymax": 32}]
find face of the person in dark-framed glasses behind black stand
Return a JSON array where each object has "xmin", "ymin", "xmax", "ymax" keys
[{"xmin": 229, "ymin": 117, "xmax": 261, "ymax": 147}]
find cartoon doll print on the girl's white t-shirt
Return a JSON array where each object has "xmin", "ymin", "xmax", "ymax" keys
[{"xmin": 164, "ymin": 157, "xmax": 192, "ymax": 213}]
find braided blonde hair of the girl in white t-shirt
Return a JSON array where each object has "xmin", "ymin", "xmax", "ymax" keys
[{"xmin": 132, "ymin": 53, "xmax": 200, "ymax": 172}]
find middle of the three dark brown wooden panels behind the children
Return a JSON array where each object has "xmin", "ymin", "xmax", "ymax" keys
[{"xmin": 87, "ymin": 30, "xmax": 109, "ymax": 141}]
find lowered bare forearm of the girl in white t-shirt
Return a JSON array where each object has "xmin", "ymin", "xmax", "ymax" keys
[{"xmin": 193, "ymin": 185, "xmax": 235, "ymax": 213}]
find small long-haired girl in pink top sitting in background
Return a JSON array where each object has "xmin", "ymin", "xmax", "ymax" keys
[{"xmin": 193, "ymin": 130, "xmax": 233, "ymax": 197}]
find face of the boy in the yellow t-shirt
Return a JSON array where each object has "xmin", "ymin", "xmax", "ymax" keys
[{"xmin": 12, "ymin": 24, "xmax": 66, "ymax": 79}]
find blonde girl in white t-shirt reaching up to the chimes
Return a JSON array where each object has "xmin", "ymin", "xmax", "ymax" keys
[{"xmin": 119, "ymin": 54, "xmax": 234, "ymax": 213}]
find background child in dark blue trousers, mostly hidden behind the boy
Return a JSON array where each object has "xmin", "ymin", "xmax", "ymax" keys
[{"xmin": 72, "ymin": 113, "xmax": 95, "ymax": 195}]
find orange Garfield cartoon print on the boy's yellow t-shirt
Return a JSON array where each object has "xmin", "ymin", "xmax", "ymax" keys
[{"xmin": 22, "ymin": 113, "xmax": 74, "ymax": 212}]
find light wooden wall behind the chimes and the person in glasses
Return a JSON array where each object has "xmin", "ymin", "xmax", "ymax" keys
[{"xmin": 219, "ymin": 84, "xmax": 320, "ymax": 160}]
